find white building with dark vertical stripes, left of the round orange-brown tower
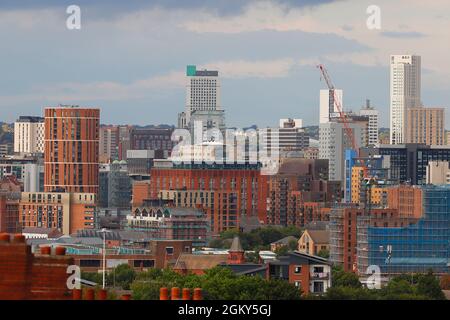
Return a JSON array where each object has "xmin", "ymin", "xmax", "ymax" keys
[{"xmin": 14, "ymin": 116, "xmax": 45, "ymax": 154}]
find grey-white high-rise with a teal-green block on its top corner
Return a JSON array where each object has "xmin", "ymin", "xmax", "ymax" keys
[{"xmin": 185, "ymin": 65, "xmax": 222, "ymax": 127}]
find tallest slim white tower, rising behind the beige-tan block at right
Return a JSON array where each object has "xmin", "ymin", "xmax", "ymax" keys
[{"xmin": 390, "ymin": 55, "xmax": 421, "ymax": 144}]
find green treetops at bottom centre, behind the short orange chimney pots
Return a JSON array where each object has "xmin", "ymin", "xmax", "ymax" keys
[{"xmin": 131, "ymin": 267, "xmax": 301, "ymax": 300}]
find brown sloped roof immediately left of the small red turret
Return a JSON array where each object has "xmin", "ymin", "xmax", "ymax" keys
[{"xmin": 173, "ymin": 253, "xmax": 228, "ymax": 270}]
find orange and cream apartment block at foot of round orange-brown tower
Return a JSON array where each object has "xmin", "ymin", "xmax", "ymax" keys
[{"xmin": 19, "ymin": 192, "xmax": 97, "ymax": 235}]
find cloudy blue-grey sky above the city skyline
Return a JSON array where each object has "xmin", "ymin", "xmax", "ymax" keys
[{"xmin": 0, "ymin": 0, "xmax": 450, "ymax": 128}]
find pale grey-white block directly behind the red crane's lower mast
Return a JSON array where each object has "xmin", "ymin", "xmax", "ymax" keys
[{"xmin": 319, "ymin": 121, "xmax": 367, "ymax": 184}]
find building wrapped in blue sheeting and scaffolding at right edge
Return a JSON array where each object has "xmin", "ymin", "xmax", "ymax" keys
[{"xmin": 357, "ymin": 186, "xmax": 450, "ymax": 274}]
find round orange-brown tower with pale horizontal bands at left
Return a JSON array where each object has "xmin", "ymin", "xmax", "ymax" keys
[{"xmin": 44, "ymin": 106, "xmax": 100, "ymax": 194}]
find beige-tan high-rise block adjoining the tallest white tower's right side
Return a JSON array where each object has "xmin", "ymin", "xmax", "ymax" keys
[{"xmin": 406, "ymin": 107, "xmax": 445, "ymax": 146}]
